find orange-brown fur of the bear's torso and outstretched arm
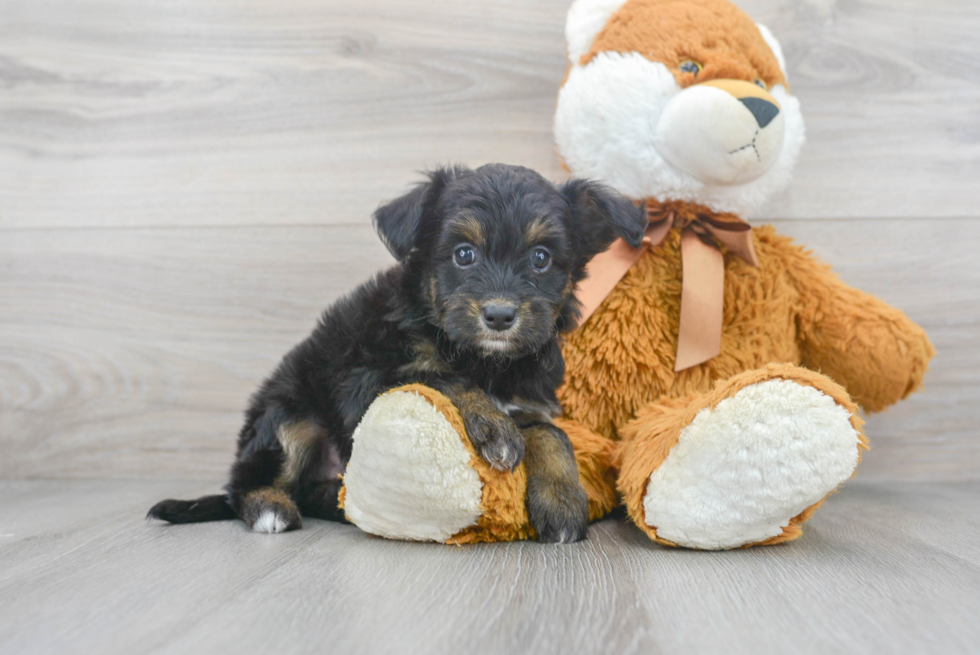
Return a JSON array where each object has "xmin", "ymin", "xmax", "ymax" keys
[{"xmin": 559, "ymin": 217, "xmax": 934, "ymax": 439}]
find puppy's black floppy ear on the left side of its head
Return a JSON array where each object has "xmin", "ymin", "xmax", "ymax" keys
[{"xmin": 374, "ymin": 166, "xmax": 468, "ymax": 261}]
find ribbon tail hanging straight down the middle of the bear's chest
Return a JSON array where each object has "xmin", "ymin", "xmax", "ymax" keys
[{"xmin": 674, "ymin": 230, "xmax": 728, "ymax": 372}]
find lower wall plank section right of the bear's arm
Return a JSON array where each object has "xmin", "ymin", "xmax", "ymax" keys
[{"xmin": 776, "ymin": 219, "xmax": 980, "ymax": 480}]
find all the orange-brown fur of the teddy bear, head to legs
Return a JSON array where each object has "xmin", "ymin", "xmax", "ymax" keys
[{"xmin": 344, "ymin": 0, "xmax": 935, "ymax": 545}]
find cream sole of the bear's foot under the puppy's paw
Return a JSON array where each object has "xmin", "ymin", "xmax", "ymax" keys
[{"xmin": 344, "ymin": 391, "xmax": 483, "ymax": 541}]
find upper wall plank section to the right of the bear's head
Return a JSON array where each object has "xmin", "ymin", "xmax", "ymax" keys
[{"xmin": 738, "ymin": 0, "xmax": 980, "ymax": 218}]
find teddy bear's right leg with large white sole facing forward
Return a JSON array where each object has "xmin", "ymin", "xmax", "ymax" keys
[{"xmin": 618, "ymin": 364, "xmax": 867, "ymax": 550}]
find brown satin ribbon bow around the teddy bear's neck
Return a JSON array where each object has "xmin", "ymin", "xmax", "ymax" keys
[{"xmin": 576, "ymin": 201, "xmax": 759, "ymax": 371}]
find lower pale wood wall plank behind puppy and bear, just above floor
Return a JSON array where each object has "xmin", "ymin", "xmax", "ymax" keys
[{"xmin": 0, "ymin": 219, "xmax": 980, "ymax": 483}]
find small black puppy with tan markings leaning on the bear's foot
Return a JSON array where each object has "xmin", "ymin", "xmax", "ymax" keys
[{"xmin": 149, "ymin": 164, "xmax": 647, "ymax": 542}]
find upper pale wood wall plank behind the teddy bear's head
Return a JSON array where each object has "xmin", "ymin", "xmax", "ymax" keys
[{"xmin": 0, "ymin": 0, "xmax": 980, "ymax": 228}]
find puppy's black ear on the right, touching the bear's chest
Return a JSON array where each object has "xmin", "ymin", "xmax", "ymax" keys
[{"xmin": 561, "ymin": 179, "xmax": 649, "ymax": 266}]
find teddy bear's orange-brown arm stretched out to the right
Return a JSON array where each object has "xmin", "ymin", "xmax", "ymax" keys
[{"xmin": 787, "ymin": 246, "xmax": 935, "ymax": 412}]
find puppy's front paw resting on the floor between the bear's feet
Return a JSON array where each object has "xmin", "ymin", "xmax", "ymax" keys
[{"xmin": 527, "ymin": 480, "xmax": 589, "ymax": 544}]
